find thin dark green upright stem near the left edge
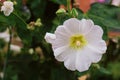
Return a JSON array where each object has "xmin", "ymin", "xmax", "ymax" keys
[{"xmin": 2, "ymin": 26, "xmax": 12, "ymax": 80}]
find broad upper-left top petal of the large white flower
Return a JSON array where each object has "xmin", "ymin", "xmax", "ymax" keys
[{"xmin": 63, "ymin": 18, "xmax": 80, "ymax": 34}]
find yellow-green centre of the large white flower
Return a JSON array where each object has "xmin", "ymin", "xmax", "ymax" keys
[{"xmin": 69, "ymin": 34, "xmax": 87, "ymax": 49}]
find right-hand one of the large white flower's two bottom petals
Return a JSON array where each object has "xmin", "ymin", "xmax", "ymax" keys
[{"xmin": 76, "ymin": 50, "xmax": 91, "ymax": 72}]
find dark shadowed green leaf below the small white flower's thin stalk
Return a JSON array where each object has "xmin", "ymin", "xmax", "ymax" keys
[{"xmin": 13, "ymin": 13, "xmax": 32, "ymax": 44}]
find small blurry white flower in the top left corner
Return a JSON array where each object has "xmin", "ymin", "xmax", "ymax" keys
[{"xmin": 1, "ymin": 1, "xmax": 14, "ymax": 16}]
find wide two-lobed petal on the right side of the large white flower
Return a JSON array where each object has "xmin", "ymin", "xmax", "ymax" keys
[{"xmin": 85, "ymin": 25, "xmax": 107, "ymax": 54}]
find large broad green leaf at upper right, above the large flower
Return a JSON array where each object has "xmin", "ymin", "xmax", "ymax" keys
[{"xmin": 88, "ymin": 3, "xmax": 120, "ymax": 29}]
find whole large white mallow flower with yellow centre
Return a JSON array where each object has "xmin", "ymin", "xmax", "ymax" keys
[{"xmin": 45, "ymin": 18, "xmax": 107, "ymax": 72}]
